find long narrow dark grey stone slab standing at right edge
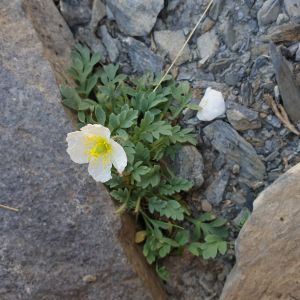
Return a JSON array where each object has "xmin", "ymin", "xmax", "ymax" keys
[{"xmin": 270, "ymin": 42, "xmax": 300, "ymax": 123}]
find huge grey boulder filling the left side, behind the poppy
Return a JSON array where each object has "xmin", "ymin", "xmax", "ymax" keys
[{"xmin": 0, "ymin": 0, "xmax": 166, "ymax": 300}]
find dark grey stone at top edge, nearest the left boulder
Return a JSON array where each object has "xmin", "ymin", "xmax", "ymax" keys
[{"xmin": 59, "ymin": 0, "xmax": 92, "ymax": 28}]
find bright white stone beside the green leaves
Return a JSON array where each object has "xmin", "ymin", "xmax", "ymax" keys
[{"xmin": 197, "ymin": 88, "xmax": 225, "ymax": 121}]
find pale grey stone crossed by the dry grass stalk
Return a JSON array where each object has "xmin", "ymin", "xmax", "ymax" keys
[{"xmin": 154, "ymin": 30, "xmax": 190, "ymax": 65}]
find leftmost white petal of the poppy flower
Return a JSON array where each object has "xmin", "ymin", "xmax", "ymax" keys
[{"xmin": 66, "ymin": 131, "xmax": 89, "ymax": 164}]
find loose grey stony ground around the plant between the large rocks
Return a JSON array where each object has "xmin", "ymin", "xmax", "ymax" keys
[{"xmin": 54, "ymin": 0, "xmax": 300, "ymax": 299}]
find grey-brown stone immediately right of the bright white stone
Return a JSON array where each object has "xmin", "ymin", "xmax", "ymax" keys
[{"xmin": 226, "ymin": 101, "xmax": 261, "ymax": 130}]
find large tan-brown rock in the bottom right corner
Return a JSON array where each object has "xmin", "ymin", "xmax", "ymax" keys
[{"xmin": 220, "ymin": 164, "xmax": 300, "ymax": 300}]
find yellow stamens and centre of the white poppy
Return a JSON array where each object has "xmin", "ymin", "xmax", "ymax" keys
[{"xmin": 81, "ymin": 135, "xmax": 111, "ymax": 169}]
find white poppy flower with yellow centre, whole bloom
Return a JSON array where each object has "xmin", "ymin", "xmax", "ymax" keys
[{"xmin": 67, "ymin": 124, "xmax": 127, "ymax": 182}]
